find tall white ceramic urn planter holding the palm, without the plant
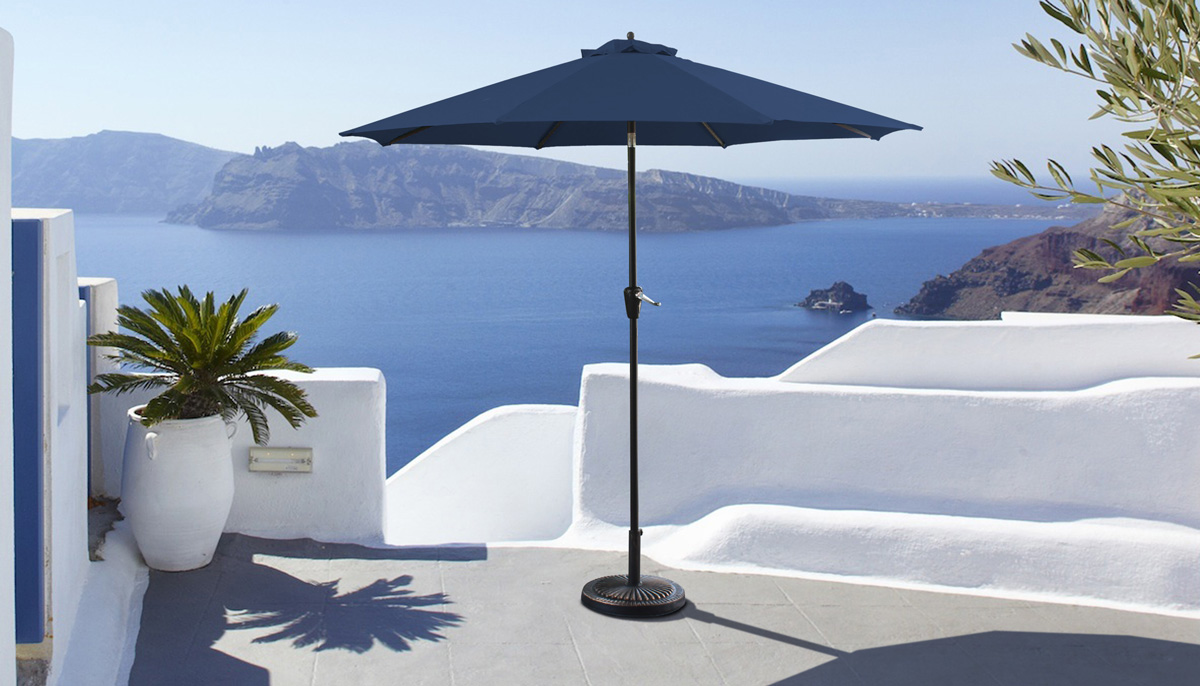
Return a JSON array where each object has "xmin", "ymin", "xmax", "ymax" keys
[{"xmin": 121, "ymin": 408, "xmax": 233, "ymax": 572}]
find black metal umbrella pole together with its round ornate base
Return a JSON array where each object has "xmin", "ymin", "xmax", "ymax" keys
[{"xmin": 582, "ymin": 121, "xmax": 688, "ymax": 618}]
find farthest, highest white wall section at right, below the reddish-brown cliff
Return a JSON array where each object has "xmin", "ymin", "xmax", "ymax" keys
[{"xmin": 778, "ymin": 313, "xmax": 1200, "ymax": 391}]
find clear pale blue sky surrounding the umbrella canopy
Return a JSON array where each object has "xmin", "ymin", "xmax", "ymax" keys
[{"xmin": 0, "ymin": 0, "xmax": 1120, "ymax": 179}]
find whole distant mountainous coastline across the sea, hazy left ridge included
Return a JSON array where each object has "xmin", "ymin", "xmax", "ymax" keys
[{"xmin": 13, "ymin": 131, "xmax": 1086, "ymax": 231}]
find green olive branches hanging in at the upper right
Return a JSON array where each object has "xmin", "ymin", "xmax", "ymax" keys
[{"xmin": 991, "ymin": 0, "xmax": 1200, "ymax": 321}]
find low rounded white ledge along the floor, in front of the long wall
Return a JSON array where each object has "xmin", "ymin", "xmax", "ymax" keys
[{"xmin": 646, "ymin": 505, "xmax": 1200, "ymax": 619}]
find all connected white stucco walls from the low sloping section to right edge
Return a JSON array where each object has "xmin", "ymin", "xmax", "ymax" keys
[{"xmin": 388, "ymin": 315, "xmax": 1200, "ymax": 612}]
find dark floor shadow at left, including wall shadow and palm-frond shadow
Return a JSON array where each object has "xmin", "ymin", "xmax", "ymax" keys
[{"xmin": 130, "ymin": 535, "xmax": 475, "ymax": 686}]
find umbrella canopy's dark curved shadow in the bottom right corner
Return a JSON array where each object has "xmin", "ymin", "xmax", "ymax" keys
[{"xmin": 775, "ymin": 631, "xmax": 1200, "ymax": 686}]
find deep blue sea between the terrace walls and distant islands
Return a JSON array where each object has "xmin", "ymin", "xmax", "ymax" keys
[{"xmin": 76, "ymin": 209, "xmax": 1051, "ymax": 474}]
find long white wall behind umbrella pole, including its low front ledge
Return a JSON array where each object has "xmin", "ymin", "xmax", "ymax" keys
[{"xmin": 568, "ymin": 359, "xmax": 1200, "ymax": 616}]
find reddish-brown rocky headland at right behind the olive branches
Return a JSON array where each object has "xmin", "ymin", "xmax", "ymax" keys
[{"xmin": 896, "ymin": 206, "xmax": 1200, "ymax": 319}]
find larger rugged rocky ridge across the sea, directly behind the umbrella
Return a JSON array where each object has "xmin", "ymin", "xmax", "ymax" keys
[{"xmin": 167, "ymin": 142, "xmax": 1094, "ymax": 231}]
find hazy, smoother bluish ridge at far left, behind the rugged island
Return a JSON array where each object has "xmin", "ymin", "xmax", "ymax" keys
[{"xmin": 12, "ymin": 131, "xmax": 235, "ymax": 215}]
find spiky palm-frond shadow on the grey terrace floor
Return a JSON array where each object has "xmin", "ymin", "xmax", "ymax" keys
[{"xmin": 226, "ymin": 574, "xmax": 462, "ymax": 652}]
